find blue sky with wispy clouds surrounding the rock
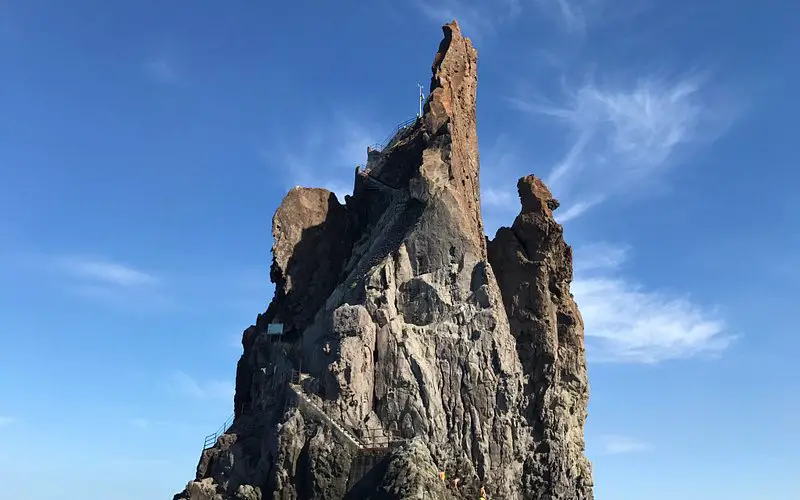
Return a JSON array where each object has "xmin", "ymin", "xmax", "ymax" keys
[{"xmin": 0, "ymin": 0, "xmax": 800, "ymax": 500}]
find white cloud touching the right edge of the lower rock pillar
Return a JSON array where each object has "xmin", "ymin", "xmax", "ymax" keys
[{"xmin": 572, "ymin": 244, "xmax": 735, "ymax": 363}]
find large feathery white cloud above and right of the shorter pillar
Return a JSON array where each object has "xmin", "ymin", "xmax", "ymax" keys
[{"xmin": 510, "ymin": 74, "xmax": 735, "ymax": 222}]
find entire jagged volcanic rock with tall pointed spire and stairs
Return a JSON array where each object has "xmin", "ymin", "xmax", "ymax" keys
[{"xmin": 175, "ymin": 22, "xmax": 593, "ymax": 500}]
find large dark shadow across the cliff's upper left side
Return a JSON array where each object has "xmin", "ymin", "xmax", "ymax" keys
[{"xmin": 234, "ymin": 180, "xmax": 425, "ymax": 410}]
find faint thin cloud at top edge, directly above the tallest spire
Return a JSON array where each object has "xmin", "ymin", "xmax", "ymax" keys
[{"xmin": 414, "ymin": 0, "xmax": 522, "ymax": 40}]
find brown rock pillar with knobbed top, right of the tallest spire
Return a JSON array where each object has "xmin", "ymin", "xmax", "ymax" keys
[{"xmin": 489, "ymin": 175, "xmax": 593, "ymax": 500}]
